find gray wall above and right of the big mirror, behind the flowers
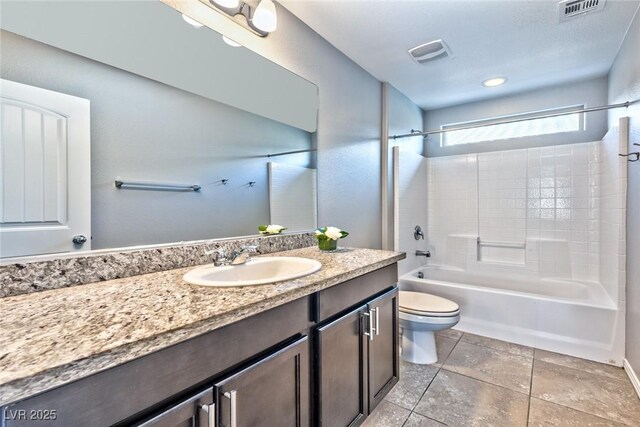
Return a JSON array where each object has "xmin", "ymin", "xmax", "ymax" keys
[{"xmin": 171, "ymin": 2, "xmax": 382, "ymax": 248}]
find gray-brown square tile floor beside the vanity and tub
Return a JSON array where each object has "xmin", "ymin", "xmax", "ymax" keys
[{"xmin": 364, "ymin": 330, "xmax": 640, "ymax": 427}]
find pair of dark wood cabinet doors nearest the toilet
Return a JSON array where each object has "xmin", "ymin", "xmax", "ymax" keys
[{"xmin": 315, "ymin": 288, "xmax": 399, "ymax": 426}]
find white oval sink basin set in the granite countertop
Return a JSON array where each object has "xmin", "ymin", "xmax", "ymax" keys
[{"xmin": 183, "ymin": 257, "xmax": 322, "ymax": 286}]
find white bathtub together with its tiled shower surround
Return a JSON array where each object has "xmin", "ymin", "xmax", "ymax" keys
[{"xmin": 396, "ymin": 118, "xmax": 627, "ymax": 366}]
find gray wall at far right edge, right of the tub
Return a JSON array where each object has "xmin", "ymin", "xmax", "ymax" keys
[{"xmin": 609, "ymin": 5, "xmax": 640, "ymax": 375}]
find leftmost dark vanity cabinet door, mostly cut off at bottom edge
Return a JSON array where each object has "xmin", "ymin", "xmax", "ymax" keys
[{"xmin": 134, "ymin": 388, "xmax": 215, "ymax": 427}]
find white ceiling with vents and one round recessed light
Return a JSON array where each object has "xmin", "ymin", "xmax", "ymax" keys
[{"xmin": 278, "ymin": 0, "xmax": 640, "ymax": 110}]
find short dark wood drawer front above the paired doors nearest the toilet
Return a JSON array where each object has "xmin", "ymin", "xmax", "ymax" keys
[{"xmin": 313, "ymin": 264, "xmax": 398, "ymax": 322}]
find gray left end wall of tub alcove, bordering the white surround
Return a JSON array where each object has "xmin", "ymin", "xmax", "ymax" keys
[{"xmin": 385, "ymin": 83, "xmax": 426, "ymax": 249}]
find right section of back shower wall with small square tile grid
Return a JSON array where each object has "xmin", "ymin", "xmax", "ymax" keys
[{"xmin": 526, "ymin": 142, "xmax": 600, "ymax": 282}]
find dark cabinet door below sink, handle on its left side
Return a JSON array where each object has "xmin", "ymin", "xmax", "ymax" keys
[{"xmin": 214, "ymin": 337, "xmax": 309, "ymax": 427}]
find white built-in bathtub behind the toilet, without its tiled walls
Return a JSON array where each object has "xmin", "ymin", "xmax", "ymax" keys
[{"xmin": 399, "ymin": 266, "xmax": 624, "ymax": 366}]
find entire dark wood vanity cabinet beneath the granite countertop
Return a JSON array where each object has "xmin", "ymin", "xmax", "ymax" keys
[{"xmin": 0, "ymin": 264, "xmax": 399, "ymax": 427}]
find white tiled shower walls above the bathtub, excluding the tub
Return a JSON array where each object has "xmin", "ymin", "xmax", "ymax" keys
[{"xmin": 398, "ymin": 135, "xmax": 626, "ymax": 302}]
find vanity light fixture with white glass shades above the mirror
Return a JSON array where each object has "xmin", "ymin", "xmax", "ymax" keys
[{"xmin": 208, "ymin": 0, "xmax": 278, "ymax": 36}]
